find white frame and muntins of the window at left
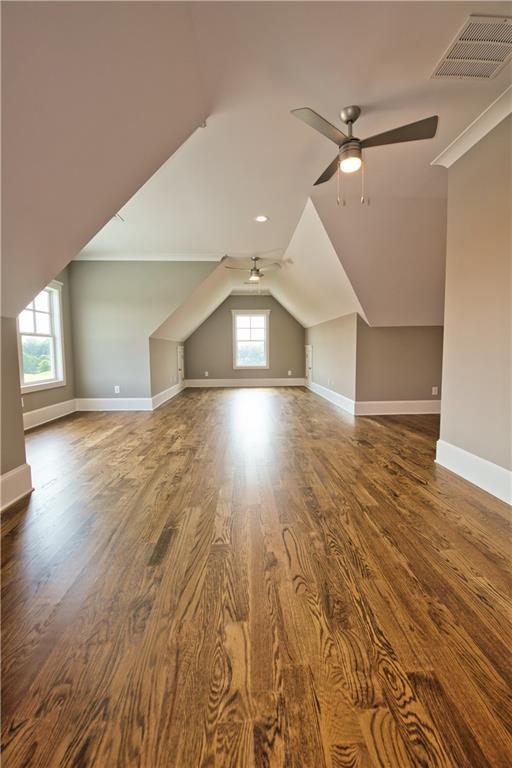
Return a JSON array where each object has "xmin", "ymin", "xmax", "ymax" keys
[{"xmin": 16, "ymin": 280, "xmax": 66, "ymax": 395}]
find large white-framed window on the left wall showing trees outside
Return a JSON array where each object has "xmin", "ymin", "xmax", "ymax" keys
[{"xmin": 18, "ymin": 282, "xmax": 65, "ymax": 392}]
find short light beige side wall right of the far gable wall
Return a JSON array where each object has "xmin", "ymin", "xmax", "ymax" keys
[{"xmin": 306, "ymin": 312, "xmax": 357, "ymax": 400}]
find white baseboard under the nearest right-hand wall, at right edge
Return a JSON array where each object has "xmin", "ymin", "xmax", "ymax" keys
[{"xmin": 436, "ymin": 440, "xmax": 512, "ymax": 505}]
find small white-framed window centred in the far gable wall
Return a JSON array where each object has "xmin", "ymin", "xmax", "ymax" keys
[{"xmin": 232, "ymin": 309, "xmax": 270, "ymax": 368}]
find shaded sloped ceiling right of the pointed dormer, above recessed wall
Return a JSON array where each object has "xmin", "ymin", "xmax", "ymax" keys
[{"xmin": 314, "ymin": 191, "xmax": 446, "ymax": 325}]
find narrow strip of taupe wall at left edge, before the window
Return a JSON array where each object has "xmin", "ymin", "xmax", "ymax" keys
[{"xmin": 1, "ymin": 317, "xmax": 25, "ymax": 474}]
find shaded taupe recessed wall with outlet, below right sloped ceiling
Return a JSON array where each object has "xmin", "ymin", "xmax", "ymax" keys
[{"xmin": 356, "ymin": 317, "xmax": 443, "ymax": 401}]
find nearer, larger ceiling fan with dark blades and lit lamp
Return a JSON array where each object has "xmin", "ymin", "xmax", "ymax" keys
[{"xmin": 291, "ymin": 106, "xmax": 439, "ymax": 186}]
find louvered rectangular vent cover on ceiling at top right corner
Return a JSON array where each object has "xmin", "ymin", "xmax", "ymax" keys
[{"xmin": 432, "ymin": 16, "xmax": 512, "ymax": 80}]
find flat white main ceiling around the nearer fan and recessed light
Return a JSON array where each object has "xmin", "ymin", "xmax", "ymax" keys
[{"xmin": 82, "ymin": 2, "xmax": 511, "ymax": 254}]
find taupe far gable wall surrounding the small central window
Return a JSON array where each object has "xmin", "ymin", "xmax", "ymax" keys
[{"xmin": 185, "ymin": 296, "xmax": 305, "ymax": 379}]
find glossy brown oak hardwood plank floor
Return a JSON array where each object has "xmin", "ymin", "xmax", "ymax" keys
[{"xmin": 2, "ymin": 388, "xmax": 512, "ymax": 768}]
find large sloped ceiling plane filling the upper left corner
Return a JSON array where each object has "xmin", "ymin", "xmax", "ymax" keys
[{"xmin": 2, "ymin": 2, "xmax": 208, "ymax": 315}]
